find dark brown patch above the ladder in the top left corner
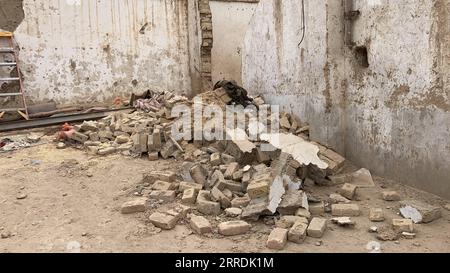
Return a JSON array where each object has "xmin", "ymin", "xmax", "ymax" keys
[{"xmin": 0, "ymin": 0, "xmax": 24, "ymax": 32}]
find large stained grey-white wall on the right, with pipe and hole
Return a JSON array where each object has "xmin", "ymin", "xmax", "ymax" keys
[{"xmin": 243, "ymin": 0, "xmax": 450, "ymax": 198}]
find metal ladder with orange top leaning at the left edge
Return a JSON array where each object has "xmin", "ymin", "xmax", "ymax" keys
[{"xmin": 0, "ymin": 31, "xmax": 29, "ymax": 120}]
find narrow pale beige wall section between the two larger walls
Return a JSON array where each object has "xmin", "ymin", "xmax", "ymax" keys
[{"xmin": 210, "ymin": 0, "xmax": 259, "ymax": 84}]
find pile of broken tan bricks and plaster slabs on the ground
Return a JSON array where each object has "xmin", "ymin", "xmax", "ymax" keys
[{"xmin": 58, "ymin": 88, "xmax": 440, "ymax": 250}]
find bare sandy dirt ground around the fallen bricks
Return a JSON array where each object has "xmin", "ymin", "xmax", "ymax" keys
[{"xmin": 0, "ymin": 131, "xmax": 450, "ymax": 253}]
